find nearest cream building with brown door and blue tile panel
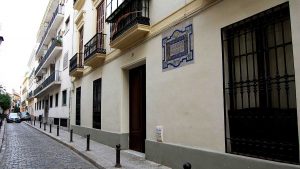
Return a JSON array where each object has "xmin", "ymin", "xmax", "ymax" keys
[{"xmin": 65, "ymin": 0, "xmax": 300, "ymax": 169}]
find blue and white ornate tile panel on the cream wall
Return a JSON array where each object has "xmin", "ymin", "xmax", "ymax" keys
[{"xmin": 162, "ymin": 20, "xmax": 194, "ymax": 71}]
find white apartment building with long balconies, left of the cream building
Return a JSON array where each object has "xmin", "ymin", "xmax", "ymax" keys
[{"xmin": 34, "ymin": 0, "xmax": 73, "ymax": 127}]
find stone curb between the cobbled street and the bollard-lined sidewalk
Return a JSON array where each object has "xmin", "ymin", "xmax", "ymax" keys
[{"xmin": 24, "ymin": 122, "xmax": 105, "ymax": 169}]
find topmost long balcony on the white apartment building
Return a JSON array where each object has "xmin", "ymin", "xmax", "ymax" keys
[{"xmin": 36, "ymin": 5, "xmax": 64, "ymax": 56}]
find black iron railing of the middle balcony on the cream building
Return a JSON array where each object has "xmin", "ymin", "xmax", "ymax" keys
[{"xmin": 84, "ymin": 33, "xmax": 106, "ymax": 61}]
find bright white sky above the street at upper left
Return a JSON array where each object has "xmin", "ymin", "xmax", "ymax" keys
[{"xmin": 0, "ymin": 0, "xmax": 49, "ymax": 93}]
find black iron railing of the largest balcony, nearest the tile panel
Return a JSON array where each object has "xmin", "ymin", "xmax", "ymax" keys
[{"xmin": 106, "ymin": 0, "xmax": 150, "ymax": 41}]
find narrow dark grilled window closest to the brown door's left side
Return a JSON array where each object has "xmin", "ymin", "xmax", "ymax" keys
[{"xmin": 93, "ymin": 79, "xmax": 101, "ymax": 129}]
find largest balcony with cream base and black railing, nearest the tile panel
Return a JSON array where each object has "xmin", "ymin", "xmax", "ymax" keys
[{"xmin": 106, "ymin": 0, "xmax": 150, "ymax": 49}]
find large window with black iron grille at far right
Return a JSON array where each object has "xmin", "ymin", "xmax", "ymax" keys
[{"xmin": 222, "ymin": 3, "xmax": 299, "ymax": 163}]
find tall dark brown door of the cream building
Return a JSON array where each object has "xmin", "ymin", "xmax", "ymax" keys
[{"xmin": 129, "ymin": 65, "xmax": 146, "ymax": 152}]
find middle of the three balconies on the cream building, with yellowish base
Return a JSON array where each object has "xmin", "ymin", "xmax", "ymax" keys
[{"xmin": 84, "ymin": 33, "xmax": 106, "ymax": 67}]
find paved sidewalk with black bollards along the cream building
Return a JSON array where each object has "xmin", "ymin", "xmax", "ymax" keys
[{"xmin": 25, "ymin": 121, "xmax": 170, "ymax": 169}]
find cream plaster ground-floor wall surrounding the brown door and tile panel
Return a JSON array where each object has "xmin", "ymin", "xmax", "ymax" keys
[{"xmin": 71, "ymin": 0, "xmax": 300, "ymax": 152}]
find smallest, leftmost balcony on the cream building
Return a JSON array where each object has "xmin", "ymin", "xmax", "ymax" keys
[{"xmin": 69, "ymin": 53, "xmax": 84, "ymax": 77}]
